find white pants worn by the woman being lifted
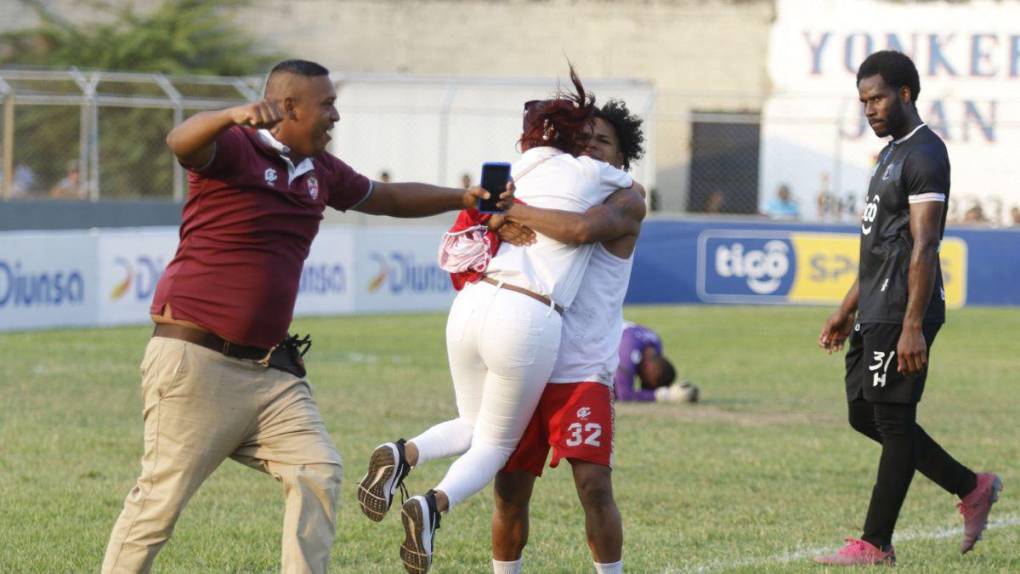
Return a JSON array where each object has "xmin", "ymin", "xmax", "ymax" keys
[{"xmin": 411, "ymin": 282, "xmax": 561, "ymax": 509}]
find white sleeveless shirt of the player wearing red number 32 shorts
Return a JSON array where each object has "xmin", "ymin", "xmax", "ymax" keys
[{"xmin": 549, "ymin": 244, "xmax": 634, "ymax": 386}]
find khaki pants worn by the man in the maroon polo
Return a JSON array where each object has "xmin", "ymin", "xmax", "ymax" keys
[{"xmin": 102, "ymin": 337, "xmax": 343, "ymax": 573}]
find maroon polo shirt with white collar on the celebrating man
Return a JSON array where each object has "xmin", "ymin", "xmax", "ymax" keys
[{"xmin": 151, "ymin": 126, "xmax": 371, "ymax": 349}]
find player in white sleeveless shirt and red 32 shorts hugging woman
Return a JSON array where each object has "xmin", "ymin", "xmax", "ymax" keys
[{"xmin": 493, "ymin": 100, "xmax": 646, "ymax": 574}]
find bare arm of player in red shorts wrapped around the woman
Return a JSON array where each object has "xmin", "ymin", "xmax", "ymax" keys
[{"xmin": 506, "ymin": 184, "xmax": 646, "ymax": 244}]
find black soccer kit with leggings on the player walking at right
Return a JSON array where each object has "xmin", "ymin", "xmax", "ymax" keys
[{"xmin": 846, "ymin": 123, "xmax": 977, "ymax": 547}]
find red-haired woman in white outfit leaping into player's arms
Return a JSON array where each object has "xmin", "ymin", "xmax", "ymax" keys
[{"xmin": 358, "ymin": 68, "xmax": 633, "ymax": 573}]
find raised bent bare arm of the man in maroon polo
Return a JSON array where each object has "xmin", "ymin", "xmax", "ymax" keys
[{"xmin": 166, "ymin": 100, "xmax": 284, "ymax": 167}]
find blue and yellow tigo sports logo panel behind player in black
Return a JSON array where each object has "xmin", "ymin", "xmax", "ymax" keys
[{"xmin": 698, "ymin": 230, "xmax": 967, "ymax": 308}]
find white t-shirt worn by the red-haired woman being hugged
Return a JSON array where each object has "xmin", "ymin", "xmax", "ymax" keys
[{"xmin": 486, "ymin": 147, "xmax": 633, "ymax": 307}]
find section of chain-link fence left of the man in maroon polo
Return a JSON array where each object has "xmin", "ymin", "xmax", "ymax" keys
[{"xmin": 0, "ymin": 69, "xmax": 259, "ymax": 200}]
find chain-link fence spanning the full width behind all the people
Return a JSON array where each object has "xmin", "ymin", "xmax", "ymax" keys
[{"xmin": 0, "ymin": 69, "xmax": 1020, "ymax": 225}]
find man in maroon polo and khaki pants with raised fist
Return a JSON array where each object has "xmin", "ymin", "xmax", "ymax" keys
[{"xmin": 102, "ymin": 60, "xmax": 509, "ymax": 573}]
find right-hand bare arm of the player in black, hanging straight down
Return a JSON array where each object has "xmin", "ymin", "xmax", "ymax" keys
[{"xmin": 897, "ymin": 202, "xmax": 945, "ymax": 374}]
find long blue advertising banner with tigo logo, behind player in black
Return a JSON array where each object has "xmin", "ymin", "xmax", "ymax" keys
[{"xmin": 626, "ymin": 219, "xmax": 1020, "ymax": 309}]
